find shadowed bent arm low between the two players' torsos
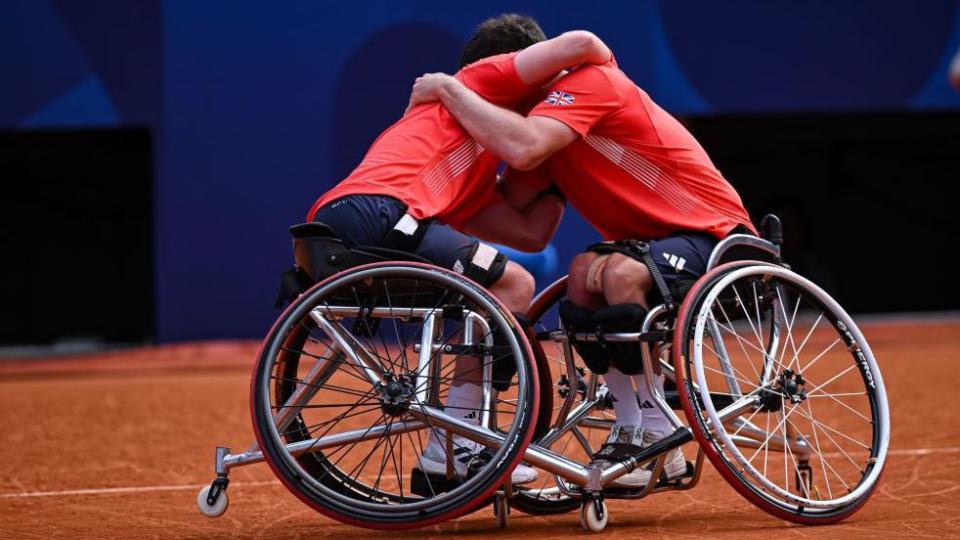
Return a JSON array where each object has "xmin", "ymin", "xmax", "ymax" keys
[{"xmin": 464, "ymin": 193, "xmax": 564, "ymax": 252}]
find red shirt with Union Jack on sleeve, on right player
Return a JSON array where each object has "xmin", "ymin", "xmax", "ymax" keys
[{"xmin": 511, "ymin": 61, "xmax": 756, "ymax": 240}]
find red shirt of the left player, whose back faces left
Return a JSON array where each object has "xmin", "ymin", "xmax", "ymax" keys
[{"xmin": 307, "ymin": 53, "xmax": 537, "ymax": 227}]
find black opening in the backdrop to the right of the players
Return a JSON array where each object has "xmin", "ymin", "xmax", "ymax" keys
[{"xmin": 688, "ymin": 112, "xmax": 960, "ymax": 313}]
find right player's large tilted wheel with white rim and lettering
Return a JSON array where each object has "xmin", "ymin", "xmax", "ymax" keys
[{"xmin": 673, "ymin": 262, "xmax": 890, "ymax": 524}]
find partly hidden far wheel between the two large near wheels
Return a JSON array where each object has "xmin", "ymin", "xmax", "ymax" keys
[{"xmin": 510, "ymin": 278, "xmax": 614, "ymax": 515}]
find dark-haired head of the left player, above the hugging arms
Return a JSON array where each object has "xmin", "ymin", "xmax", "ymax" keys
[{"xmin": 460, "ymin": 13, "xmax": 547, "ymax": 68}]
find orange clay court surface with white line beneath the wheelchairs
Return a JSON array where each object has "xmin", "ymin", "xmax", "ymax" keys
[{"xmin": 0, "ymin": 320, "xmax": 960, "ymax": 539}]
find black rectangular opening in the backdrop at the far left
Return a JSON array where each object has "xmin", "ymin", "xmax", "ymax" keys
[{"xmin": 0, "ymin": 129, "xmax": 154, "ymax": 345}]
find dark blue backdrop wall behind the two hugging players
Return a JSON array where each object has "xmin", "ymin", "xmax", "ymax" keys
[{"xmin": 0, "ymin": 0, "xmax": 960, "ymax": 341}]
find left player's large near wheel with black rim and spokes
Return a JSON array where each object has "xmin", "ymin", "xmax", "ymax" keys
[{"xmin": 251, "ymin": 263, "xmax": 538, "ymax": 529}]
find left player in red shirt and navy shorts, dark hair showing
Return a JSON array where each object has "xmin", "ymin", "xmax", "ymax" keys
[{"xmin": 307, "ymin": 14, "xmax": 611, "ymax": 489}]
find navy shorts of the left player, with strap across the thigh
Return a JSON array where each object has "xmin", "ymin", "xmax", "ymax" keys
[{"xmin": 313, "ymin": 195, "xmax": 506, "ymax": 286}]
